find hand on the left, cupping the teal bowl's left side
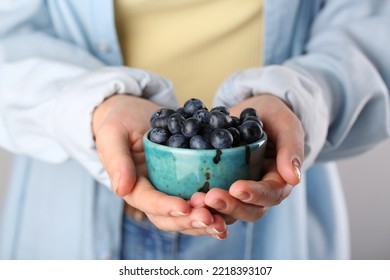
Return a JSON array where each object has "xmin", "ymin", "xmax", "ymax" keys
[{"xmin": 92, "ymin": 95, "xmax": 227, "ymax": 239}]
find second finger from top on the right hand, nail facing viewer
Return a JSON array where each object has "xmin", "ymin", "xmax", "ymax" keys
[{"xmin": 205, "ymin": 188, "xmax": 268, "ymax": 222}]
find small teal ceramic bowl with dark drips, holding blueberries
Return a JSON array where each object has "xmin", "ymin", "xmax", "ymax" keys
[{"xmin": 143, "ymin": 132, "xmax": 267, "ymax": 199}]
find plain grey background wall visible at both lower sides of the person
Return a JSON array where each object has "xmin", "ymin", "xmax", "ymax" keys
[{"xmin": 0, "ymin": 141, "xmax": 390, "ymax": 260}]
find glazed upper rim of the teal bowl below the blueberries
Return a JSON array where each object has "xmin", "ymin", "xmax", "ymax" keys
[{"xmin": 143, "ymin": 129, "xmax": 267, "ymax": 154}]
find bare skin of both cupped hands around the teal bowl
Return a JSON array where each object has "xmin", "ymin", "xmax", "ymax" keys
[{"xmin": 92, "ymin": 95, "xmax": 304, "ymax": 239}]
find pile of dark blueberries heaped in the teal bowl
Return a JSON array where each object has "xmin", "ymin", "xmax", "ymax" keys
[{"xmin": 149, "ymin": 98, "xmax": 264, "ymax": 149}]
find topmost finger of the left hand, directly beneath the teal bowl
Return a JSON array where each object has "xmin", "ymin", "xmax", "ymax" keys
[{"xmin": 124, "ymin": 177, "xmax": 191, "ymax": 217}]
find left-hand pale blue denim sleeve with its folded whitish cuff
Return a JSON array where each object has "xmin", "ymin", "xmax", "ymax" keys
[{"xmin": 0, "ymin": 0, "xmax": 176, "ymax": 188}]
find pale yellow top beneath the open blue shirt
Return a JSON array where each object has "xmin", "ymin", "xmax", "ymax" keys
[{"xmin": 115, "ymin": 0, "xmax": 263, "ymax": 108}]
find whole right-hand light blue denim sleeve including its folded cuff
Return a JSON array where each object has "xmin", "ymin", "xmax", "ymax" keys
[{"xmin": 215, "ymin": 0, "xmax": 390, "ymax": 167}]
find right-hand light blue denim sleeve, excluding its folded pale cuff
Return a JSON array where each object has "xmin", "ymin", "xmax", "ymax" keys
[{"xmin": 284, "ymin": 0, "xmax": 390, "ymax": 161}]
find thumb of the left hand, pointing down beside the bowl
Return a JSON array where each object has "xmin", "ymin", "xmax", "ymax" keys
[{"xmin": 96, "ymin": 123, "xmax": 137, "ymax": 197}]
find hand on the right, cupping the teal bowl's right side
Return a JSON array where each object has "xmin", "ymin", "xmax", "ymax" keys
[{"xmin": 191, "ymin": 95, "xmax": 304, "ymax": 223}]
